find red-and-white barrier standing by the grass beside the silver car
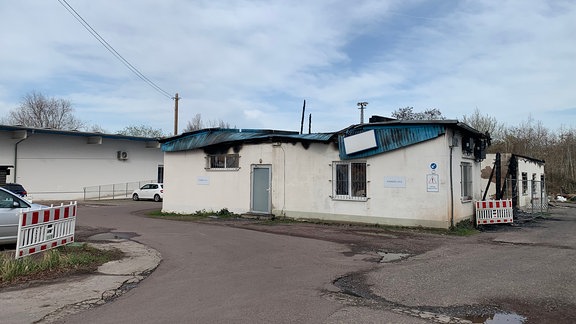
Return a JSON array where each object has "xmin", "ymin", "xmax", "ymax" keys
[{"xmin": 16, "ymin": 202, "xmax": 77, "ymax": 259}]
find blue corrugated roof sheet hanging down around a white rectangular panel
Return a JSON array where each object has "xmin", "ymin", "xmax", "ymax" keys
[{"xmin": 338, "ymin": 124, "xmax": 446, "ymax": 160}]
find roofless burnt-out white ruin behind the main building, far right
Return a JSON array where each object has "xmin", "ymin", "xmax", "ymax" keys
[{"xmin": 481, "ymin": 153, "xmax": 548, "ymax": 211}]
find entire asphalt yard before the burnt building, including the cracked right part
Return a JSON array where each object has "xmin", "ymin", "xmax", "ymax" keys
[{"xmin": 55, "ymin": 202, "xmax": 576, "ymax": 323}]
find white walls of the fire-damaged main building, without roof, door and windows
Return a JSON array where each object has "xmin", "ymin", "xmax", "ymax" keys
[{"xmin": 163, "ymin": 123, "xmax": 490, "ymax": 228}]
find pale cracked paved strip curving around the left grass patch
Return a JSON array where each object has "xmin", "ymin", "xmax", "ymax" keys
[{"xmin": 0, "ymin": 239, "xmax": 162, "ymax": 323}]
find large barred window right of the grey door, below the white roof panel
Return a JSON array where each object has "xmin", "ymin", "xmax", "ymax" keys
[{"xmin": 332, "ymin": 162, "xmax": 366, "ymax": 200}]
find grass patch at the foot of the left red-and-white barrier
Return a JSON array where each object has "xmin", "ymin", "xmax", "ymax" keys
[{"xmin": 0, "ymin": 243, "xmax": 123, "ymax": 287}]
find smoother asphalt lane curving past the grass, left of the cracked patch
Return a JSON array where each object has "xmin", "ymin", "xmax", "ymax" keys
[{"xmin": 56, "ymin": 202, "xmax": 376, "ymax": 323}]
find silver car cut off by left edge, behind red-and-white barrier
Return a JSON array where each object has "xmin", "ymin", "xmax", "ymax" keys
[{"xmin": 0, "ymin": 188, "xmax": 46, "ymax": 244}]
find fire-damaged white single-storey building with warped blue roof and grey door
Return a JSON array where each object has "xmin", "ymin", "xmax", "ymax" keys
[{"xmin": 161, "ymin": 117, "xmax": 486, "ymax": 228}]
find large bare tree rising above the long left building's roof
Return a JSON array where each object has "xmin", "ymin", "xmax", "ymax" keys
[{"xmin": 4, "ymin": 91, "xmax": 85, "ymax": 130}]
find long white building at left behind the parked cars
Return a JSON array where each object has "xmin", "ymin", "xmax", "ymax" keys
[{"xmin": 0, "ymin": 125, "xmax": 163, "ymax": 200}]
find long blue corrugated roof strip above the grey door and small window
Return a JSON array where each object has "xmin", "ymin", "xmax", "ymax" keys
[{"xmin": 161, "ymin": 128, "xmax": 335, "ymax": 152}]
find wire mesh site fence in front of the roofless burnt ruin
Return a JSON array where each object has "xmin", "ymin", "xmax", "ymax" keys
[{"xmin": 502, "ymin": 179, "xmax": 549, "ymax": 213}]
